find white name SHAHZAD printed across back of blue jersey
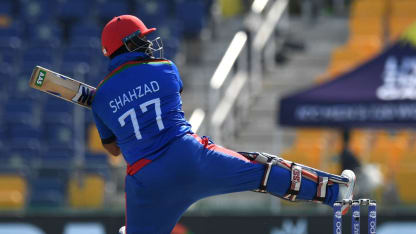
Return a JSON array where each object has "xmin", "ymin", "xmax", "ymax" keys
[{"xmin": 108, "ymin": 81, "xmax": 160, "ymax": 113}]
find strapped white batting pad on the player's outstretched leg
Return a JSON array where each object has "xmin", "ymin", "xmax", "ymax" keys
[{"xmin": 239, "ymin": 152, "xmax": 349, "ymax": 202}]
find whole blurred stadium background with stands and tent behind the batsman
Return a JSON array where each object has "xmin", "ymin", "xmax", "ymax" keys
[{"xmin": 0, "ymin": 0, "xmax": 416, "ymax": 234}]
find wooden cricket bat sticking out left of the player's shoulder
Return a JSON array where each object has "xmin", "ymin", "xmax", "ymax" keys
[{"xmin": 29, "ymin": 66, "xmax": 95, "ymax": 109}]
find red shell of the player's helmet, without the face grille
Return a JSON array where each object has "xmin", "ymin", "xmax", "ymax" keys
[{"xmin": 101, "ymin": 15, "xmax": 156, "ymax": 57}]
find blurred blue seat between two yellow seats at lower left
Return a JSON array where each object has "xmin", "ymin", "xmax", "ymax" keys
[{"xmin": 29, "ymin": 177, "xmax": 67, "ymax": 207}]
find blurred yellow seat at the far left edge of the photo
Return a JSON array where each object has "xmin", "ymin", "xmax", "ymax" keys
[{"xmin": 0, "ymin": 174, "xmax": 27, "ymax": 210}]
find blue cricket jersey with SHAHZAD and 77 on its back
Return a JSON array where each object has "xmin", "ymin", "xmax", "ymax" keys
[{"xmin": 92, "ymin": 52, "xmax": 191, "ymax": 164}]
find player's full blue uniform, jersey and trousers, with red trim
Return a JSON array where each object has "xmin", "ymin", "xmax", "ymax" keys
[{"xmin": 92, "ymin": 52, "xmax": 338, "ymax": 234}]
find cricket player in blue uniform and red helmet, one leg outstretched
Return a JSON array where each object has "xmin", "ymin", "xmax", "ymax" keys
[{"xmin": 92, "ymin": 15, "xmax": 355, "ymax": 234}]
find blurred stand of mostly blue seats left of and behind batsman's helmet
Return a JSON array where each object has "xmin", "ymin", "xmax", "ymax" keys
[{"xmin": 0, "ymin": 0, "xmax": 213, "ymax": 209}]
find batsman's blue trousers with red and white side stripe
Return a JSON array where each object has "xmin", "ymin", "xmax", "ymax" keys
[{"xmin": 122, "ymin": 135, "xmax": 354, "ymax": 234}]
